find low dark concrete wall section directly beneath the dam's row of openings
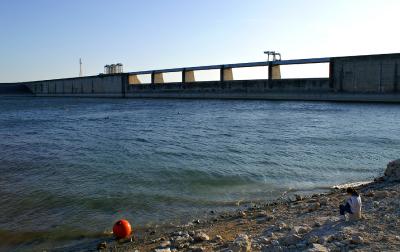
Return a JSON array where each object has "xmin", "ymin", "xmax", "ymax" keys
[{"xmin": 125, "ymin": 78, "xmax": 329, "ymax": 99}]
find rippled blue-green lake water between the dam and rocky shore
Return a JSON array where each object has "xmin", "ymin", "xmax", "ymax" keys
[{"xmin": 0, "ymin": 97, "xmax": 400, "ymax": 249}]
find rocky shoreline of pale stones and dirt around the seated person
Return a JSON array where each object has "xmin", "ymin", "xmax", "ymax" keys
[{"xmin": 89, "ymin": 160, "xmax": 400, "ymax": 252}]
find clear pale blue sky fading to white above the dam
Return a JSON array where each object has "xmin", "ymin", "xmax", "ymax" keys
[{"xmin": 0, "ymin": 0, "xmax": 400, "ymax": 82}]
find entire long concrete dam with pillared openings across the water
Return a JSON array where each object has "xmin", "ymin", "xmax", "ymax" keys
[{"xmin": 0, "ymin": 54, "xmax": 400, "ymax": 102}]
